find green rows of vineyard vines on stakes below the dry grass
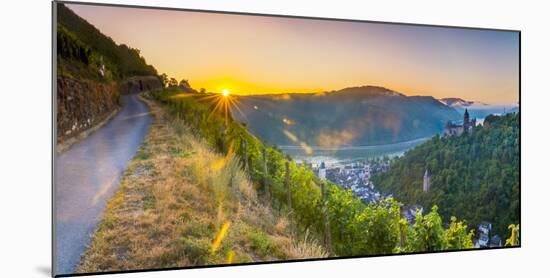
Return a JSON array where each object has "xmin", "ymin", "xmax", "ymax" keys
[{"xmin": 147, "ymin": 88, "xmax": 474, "ymax": 256}]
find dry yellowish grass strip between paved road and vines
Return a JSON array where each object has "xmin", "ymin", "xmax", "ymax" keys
[{"xmin": 77, "ymin": 94, "xmax": 326, "ymax": 272}]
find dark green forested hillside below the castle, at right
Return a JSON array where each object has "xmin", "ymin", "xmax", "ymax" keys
[{"xmin": 374, "ymin": 113, "xmax": 520, "ymax": 236}]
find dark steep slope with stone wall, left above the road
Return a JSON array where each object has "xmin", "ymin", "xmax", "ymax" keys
[{"xmin": 56, "ymin": 3, "xmax": 161, "ymax": 143}]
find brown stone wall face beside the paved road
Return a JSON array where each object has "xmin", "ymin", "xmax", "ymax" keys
[{"xmin": 57, "ymin": 76, "xmax": 120, "ymax": 142}]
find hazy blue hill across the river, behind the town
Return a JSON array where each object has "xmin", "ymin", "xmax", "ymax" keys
[{"xmin": 233, "ymin": 86, "xmax": 460, "ymax": 147}]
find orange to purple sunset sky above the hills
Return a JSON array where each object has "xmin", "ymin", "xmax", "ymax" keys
[{"xmin": 67, "ymin": 4, "xmax": 519, "ymax": 104}]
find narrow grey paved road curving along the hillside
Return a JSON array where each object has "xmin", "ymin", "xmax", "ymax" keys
[{"xmin": 54, "ymin": 95, "xmax": 152, "ymax": 274}]
